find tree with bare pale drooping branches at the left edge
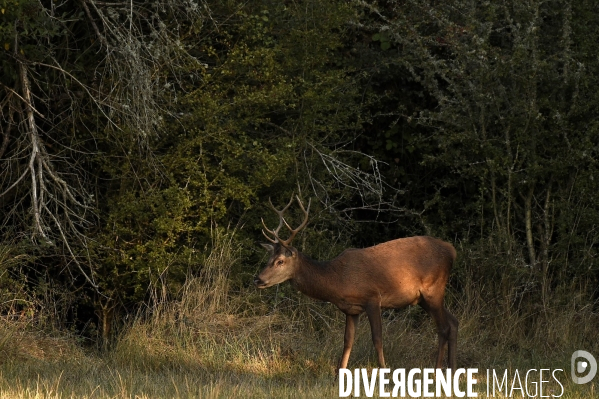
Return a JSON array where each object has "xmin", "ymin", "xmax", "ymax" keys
[{"xmin": 0, "ymin": 0, "xmax": 207, "ymax": 342}]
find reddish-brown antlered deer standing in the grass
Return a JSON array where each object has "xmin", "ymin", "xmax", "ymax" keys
[{"xmin": 254, "ymin": 195, "xmax": 459, "ymax": 373}]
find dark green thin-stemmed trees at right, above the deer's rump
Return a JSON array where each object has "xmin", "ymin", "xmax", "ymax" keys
[{"xmin": 356, "ymin": 0, "xmax": 599, "ymax": 299}]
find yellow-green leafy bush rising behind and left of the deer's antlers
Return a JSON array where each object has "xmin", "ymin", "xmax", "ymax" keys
[{"xmin": 84, "ymin": 2, "xmax": 368, "ymax": 312}]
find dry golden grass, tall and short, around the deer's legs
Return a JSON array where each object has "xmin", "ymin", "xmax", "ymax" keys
[{"xmin": 0, "ymin": 234, "xmax": 599, "ymax": 398}]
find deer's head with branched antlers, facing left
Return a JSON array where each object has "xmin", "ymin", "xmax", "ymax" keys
[{"xmin": 254, "ymin": 196, "xmax": 311, "ymax": 288}]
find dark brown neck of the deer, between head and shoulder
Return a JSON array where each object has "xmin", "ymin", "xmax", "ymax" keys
[{"xmin": 291, "ymin": 252, "xmax": 335, "ymax": 301}]
